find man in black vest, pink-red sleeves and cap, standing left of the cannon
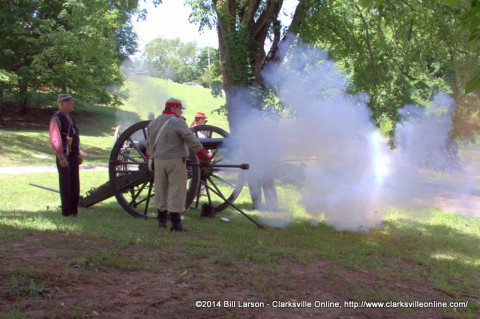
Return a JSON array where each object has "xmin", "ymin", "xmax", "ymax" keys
[{"xmin": 49, "ymin": 93, "xmax": 83, "ymax": 216}]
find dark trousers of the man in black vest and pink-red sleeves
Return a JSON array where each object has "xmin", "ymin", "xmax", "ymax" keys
[{"xmin": 57, "ymin": 154, "xmax": 80, "ymax": 216}]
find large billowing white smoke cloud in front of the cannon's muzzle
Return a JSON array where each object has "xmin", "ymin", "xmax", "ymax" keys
[{"xmin": 227, "ymin": 36, "xmax": 478, "ymax": 231}]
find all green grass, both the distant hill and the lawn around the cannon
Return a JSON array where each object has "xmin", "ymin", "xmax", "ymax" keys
[{"xmin": 0, "ymin": 77, "xmax": 480, "ymax": 318}]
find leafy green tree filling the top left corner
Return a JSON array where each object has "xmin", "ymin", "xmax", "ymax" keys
[{"xmin": 0, "ymin": 0, "xmax": 138, "ymax": 119}]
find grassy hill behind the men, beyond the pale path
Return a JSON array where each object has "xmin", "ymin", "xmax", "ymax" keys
[{"xmin": 0, "ymin": 75, "xmax": 228, "ymax": 166}]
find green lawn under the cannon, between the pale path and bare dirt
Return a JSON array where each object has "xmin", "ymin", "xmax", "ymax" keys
[{"xmin": 0, "ymin": 171, "xmax": 480, "ymax": 276}]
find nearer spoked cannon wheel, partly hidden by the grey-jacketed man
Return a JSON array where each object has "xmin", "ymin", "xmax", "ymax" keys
[{"xmin": 109, "ymin": 121, "xmax": 200, "ymax": 218}]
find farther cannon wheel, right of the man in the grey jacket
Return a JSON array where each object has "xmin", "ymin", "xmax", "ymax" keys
[{"xmin": 190, "ymin": 125, "xmax": 245, "ymax": 212}]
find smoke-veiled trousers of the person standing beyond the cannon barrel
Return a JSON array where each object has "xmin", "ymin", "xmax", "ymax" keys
[{"xmin": 248, "ymin": 177, "xmax": 278, "ymax": 210}]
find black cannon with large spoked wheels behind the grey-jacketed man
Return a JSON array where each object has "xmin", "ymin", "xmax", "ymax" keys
[{"xmin": 74, "ymin": 121, "xmax": 263, "ymax": 228}]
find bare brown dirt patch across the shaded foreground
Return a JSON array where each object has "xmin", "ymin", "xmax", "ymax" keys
[{"xmin": 0, "ymin": 233, "xmax": 464, "ymax": 318}]
